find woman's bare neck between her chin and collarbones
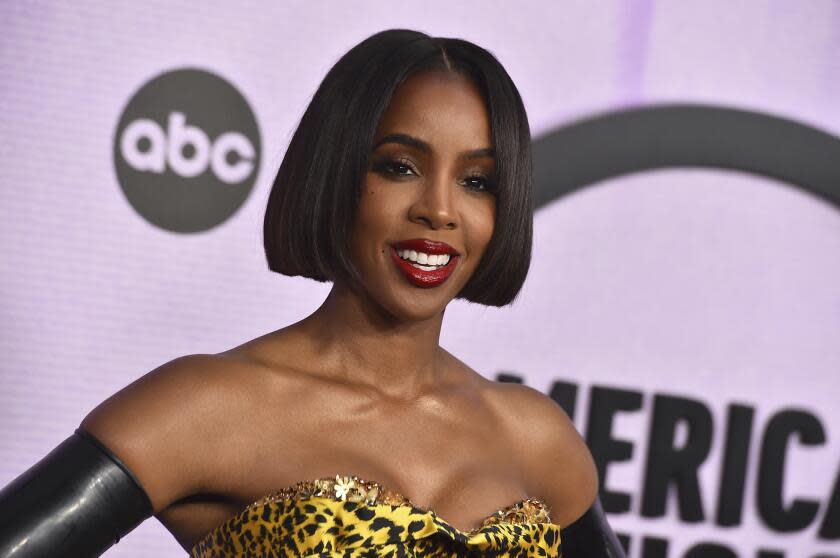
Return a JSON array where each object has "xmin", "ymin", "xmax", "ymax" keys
[{"xmin": 300, "ymin": 284, "xmax": 450, "ymax": 399}]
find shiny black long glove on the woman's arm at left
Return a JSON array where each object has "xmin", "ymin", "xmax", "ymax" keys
[{"xmin": 0, "ymin": 428, "xmax": 153, "ymax": 558}]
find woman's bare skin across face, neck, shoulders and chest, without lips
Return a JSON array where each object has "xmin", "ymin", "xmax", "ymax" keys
[{"xmin": 81, "ymin": 72, "xmax": 598, "ymax": 550}]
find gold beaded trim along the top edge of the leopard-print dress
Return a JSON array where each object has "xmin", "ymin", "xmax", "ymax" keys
[{"xmin": 206, "ymin": 474, "xmax": 551, "ymax": 536}]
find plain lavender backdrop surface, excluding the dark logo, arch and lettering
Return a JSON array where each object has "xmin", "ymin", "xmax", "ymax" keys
[{"xmin": 0, "ymin": 0, "xmax": 840, "ymax": 558}]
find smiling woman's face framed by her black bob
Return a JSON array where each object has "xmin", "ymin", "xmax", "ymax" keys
[{"xmin": 350, "ymin": 72, "xmax": 496, "ymax": 320}]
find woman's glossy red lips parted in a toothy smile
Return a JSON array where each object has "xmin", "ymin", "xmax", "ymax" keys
[{"xmin": 391, "ymin": 238, "xmax": 460, "ymax": 287}]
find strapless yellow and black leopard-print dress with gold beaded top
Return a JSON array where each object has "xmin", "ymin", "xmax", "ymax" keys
[{"xmin": 190, "ymin": 475, "xmax": 560, "ymax": 558}]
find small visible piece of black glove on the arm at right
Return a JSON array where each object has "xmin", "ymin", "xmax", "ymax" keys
[{"xmin": 560, "ymin": 498, "xmax": 625, "ymax": 558}]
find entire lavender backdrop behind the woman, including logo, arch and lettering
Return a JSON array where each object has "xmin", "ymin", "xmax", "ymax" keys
[{"xmin": 0, "ymin": 0, "xmax": 840, "ymax": 558}]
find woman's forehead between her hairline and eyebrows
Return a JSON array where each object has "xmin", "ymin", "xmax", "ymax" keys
[{"xmin": 376, "ymin": 72, "xmax": 490, "ymax": 148}]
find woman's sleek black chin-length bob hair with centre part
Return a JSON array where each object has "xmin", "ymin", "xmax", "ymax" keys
[{"xmin": 263, "ymin": 29, "xmax": 533, "ymax": 306}]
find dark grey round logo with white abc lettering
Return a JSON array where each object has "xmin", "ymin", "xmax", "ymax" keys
[{"xmin": 114, "ymin": 68, "xmax": 260, "ymax": 233}]
